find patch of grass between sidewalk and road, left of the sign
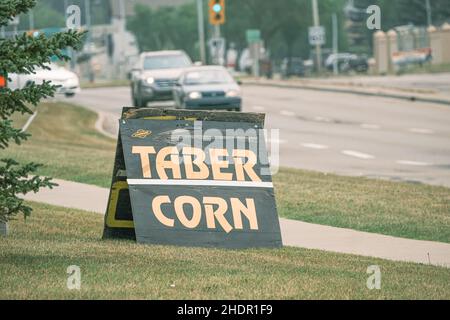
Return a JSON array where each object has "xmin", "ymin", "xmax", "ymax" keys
[{"xmin": 1, "ymin": 103, "xmax": 115, "ymax": 187}]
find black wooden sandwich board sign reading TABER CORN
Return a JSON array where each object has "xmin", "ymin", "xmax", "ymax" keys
[{"xmin": 104, "ymin": 108, "xmax": 282, "ymax": 248}]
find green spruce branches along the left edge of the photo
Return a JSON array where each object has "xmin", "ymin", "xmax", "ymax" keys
[{"xmin": 0, "ymin": 0, "xmax": 83, "ymax": 222}]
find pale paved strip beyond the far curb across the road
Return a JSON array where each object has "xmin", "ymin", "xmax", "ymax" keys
[{"xmin": 243, "ymin": 74, "xmax": 450, "ymax": 106}]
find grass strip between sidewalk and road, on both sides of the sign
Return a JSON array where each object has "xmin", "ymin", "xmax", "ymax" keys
[{"xmin": 2, "ymin": 103, "xmax": 450, "ymax": 243}]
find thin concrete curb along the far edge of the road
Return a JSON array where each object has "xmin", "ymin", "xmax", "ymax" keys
[{"xmin": 243, "ymin": 81, "xmax": 450, "ymax": 106}]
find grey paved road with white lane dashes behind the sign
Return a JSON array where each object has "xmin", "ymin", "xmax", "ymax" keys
[{"xmin": 71, "ymin": 86, "xmax": 450, "ymax": 187}]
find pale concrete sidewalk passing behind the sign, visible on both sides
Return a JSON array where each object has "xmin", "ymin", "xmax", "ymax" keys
[{"xmin": 25, "ymin": 180, "xmax": 450, "ymax": 268}]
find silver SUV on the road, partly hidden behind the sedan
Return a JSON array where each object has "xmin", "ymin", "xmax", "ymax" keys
[{"xmin": 131, "ymin": 51, "xmax": 192, "ymax": 107}]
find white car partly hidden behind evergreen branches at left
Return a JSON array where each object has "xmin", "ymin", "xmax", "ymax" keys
[{"xmin": 8, "ymin": 63, "xmax": 80, "ymax": 97}]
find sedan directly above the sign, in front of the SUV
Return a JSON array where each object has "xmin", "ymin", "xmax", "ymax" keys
[{"xmin": 173, "ymin": 66, "xmax": 242, "ymax": 111}]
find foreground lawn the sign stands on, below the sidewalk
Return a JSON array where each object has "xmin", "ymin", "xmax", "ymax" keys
[{"xmin": 0, "ymin": 203, "xmax": 450, "ymax": 299}]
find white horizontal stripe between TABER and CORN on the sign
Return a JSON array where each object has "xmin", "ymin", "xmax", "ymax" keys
[{"xmin": 127, "ymin": 179, "xmax": 273, "ymax": 188}]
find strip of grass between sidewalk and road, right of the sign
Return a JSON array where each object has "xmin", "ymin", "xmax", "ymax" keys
[{"xmin": 274, "ymin": 169, "xmax": 450, "ymax": 243}]
